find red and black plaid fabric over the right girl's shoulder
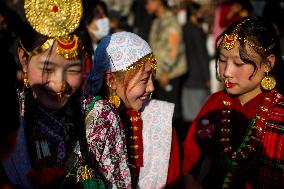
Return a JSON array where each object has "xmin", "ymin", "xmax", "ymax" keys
[{"xmin": 256, "ymin": 95, "xmax": 284, "ymax": 188}]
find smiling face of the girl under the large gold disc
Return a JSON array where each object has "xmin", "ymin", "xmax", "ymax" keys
[{"xmin": 22, "ymin": 44, "xmax": 83, "ymax": 110}]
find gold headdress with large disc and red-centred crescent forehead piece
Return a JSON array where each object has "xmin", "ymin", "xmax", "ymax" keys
[{"xmin": 24, "ymin": 0, "xmax": 83, "ymax": 59}]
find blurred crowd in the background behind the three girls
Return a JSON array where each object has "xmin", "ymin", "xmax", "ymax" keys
[{"xmin": 0, "ymin": 0, "xmax": 284, "ymax": 155}]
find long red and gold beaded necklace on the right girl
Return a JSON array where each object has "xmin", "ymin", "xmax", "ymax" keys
[{"xmin": 220, "ymin": 90, "xmax": 277, "ymax": 188}]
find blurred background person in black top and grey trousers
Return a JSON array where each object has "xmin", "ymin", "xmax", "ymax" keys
[{"xmin": 181, "ymin": 2, "xmax": 210, "ymax": 142}]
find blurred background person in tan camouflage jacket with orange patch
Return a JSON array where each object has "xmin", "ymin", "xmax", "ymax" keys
[{"xmin": 146, "ymin": 0, "xmax": 187, "ymax": 126}]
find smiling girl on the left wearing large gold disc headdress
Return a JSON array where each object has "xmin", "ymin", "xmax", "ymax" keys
[{"xmin": 2, "ymin": 0, "xmax": 105, "ymax": 189}]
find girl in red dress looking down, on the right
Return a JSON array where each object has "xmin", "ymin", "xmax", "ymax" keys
[{"xmin": 183, "ymin": 17, "xmax": 284, "ymax": 189}]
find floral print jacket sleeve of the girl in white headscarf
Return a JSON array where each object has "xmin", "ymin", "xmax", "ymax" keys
[{"xmin": 85, "ymin": 100, "xmax": 131, "ymax": 188}]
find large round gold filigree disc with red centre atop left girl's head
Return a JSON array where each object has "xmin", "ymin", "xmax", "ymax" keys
[{"xmin": 24, "ymin": 0, "xmax": 83, "ymax": 37}]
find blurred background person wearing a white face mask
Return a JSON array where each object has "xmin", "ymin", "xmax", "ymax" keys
[{"xmin": 80, "ymin": 0, "xmax": 110, "ymax": 57}]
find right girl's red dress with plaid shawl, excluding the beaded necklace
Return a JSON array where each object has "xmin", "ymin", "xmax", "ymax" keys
[{"xmin": 182, "ymin": 91, "xmax": 284, "ymax": 189}]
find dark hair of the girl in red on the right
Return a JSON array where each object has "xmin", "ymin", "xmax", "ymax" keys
[{"xmin": 216, "ymin": 17, "xmax": 284, "ymax": 92}]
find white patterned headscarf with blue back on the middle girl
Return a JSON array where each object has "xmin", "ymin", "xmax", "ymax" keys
[{"xmin": 85, "ymin": 31, "xmax": 152, "ymax": 96}]
